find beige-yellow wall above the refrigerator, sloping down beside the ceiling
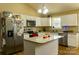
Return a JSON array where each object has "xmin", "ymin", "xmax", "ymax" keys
[{"xmin": 0, "ymin": 3, "xmax": 38, "ymax": 16}]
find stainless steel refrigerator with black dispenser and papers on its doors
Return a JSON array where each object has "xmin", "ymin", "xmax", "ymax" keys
[{"xmin": 0, "ymin": 11, "xmax": 24, "ymax": 55}]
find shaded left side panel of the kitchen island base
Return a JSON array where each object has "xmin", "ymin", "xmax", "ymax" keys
[{"xmin": 23, "ymin": 40, "xmax": 36, "ymax": 55}]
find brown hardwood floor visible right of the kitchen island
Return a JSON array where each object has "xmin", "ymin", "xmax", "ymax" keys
[{"xmin": 59, "ymin": 46, "xmax": 79, "ymax": 55}]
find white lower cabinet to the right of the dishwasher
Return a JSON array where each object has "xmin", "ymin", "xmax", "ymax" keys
[{"xmin": 68, "ymin": 33, "xmax": 78, "ymax": 47}]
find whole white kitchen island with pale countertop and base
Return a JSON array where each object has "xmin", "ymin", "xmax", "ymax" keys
[{"xmin": 24, "ymin": 33, "xmax": 63, "ymax": 55}]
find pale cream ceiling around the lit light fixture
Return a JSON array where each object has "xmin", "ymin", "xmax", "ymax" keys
[{"xmin": 28, "ymin": 3, "xmax": 79, "ymax": 14}]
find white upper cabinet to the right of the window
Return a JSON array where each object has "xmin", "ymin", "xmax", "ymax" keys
[{"xmin": 61, "ymin": 14, "xmax": 77, "ymax": 26}]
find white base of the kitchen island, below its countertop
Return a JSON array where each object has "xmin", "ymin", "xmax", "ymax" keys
[{"xmin": 23, "ymin": 39, "xmax": 58, "ymax": 55}]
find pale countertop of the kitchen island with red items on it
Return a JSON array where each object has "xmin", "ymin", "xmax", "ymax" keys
[{"xmin": 24, "ymin": 33, "xmax": 63, "ymax": 43}]
